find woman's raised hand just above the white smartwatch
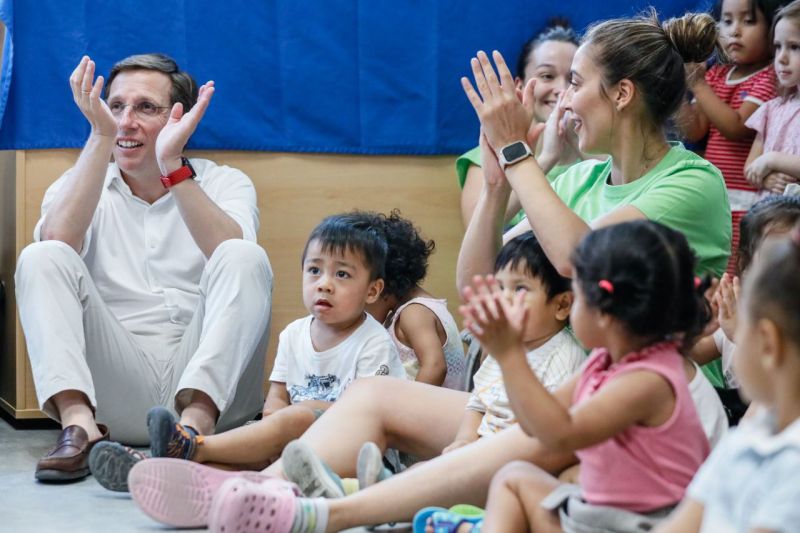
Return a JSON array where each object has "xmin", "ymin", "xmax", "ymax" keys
[{"xmin": 461, "ymin": 51, "xmax": 533, "ymax": 151}]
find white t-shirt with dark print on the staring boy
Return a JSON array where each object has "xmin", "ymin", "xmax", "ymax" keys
[{"xmin": 269, "ymin": 313, "xmax": 406, "ymax": 403}]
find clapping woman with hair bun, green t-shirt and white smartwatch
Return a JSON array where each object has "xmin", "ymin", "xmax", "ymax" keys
[{"xmin": 457, "ymin": 15, "xmax": 731, "ymax": 289}]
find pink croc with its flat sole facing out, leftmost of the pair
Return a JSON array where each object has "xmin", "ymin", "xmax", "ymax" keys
[{"xmin": 128, "ymin": 458, "xmax": 273, "ymax": 527}]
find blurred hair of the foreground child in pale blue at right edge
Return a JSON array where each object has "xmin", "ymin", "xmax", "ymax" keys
[{"xmin": 744, "ymin": 221, "xmax": 800, "ymax": 347}]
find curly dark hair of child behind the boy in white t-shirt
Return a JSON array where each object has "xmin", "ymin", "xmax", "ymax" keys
[{"xmin": 351, "ymin": 209, "xmax": 436, "ymax": 300}]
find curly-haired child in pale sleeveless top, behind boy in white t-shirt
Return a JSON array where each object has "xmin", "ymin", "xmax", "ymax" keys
[{"xmin": 361, "ymin": 210, "xmax": 466, "ymax": 390}]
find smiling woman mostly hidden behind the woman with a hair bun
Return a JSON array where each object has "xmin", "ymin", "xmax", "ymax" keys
[{"xmin": 456, "ymin": 20, "xmax": 579, "ymax": 228}]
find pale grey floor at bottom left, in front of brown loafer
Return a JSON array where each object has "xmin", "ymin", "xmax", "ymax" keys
[{"xmin": 0, "ymin": 418, "xmax": 405, "ymax": 533}]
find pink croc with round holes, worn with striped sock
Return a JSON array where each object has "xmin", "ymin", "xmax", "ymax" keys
[{"xmin": 208, "ymin": 478, "xmax": 300, "ymax": 533}]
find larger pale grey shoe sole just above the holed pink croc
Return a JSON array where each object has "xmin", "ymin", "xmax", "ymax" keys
[{"xmin": 281, "ymin": 440, "xmax": 344, "ymax": 498}]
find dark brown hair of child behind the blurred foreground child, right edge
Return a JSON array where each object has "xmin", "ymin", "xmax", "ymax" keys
[{"xmin": 736, "ymin": 196, "xmax": 800, "ymax": 276}]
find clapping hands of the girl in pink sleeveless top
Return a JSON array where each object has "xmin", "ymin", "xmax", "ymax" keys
[{"xmin": 459, "ymin": 275, "xmax": 528, "ymax": 361}]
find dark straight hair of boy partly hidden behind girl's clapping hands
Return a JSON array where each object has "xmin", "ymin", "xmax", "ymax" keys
[{"xmin": 494, "ymin": 231, "xmax": 570, "ymax": 299}]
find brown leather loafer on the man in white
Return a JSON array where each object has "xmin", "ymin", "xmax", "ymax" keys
[{"xmin": 36, "ymin": 424, "xmax": 108, "ymax": 481}]
